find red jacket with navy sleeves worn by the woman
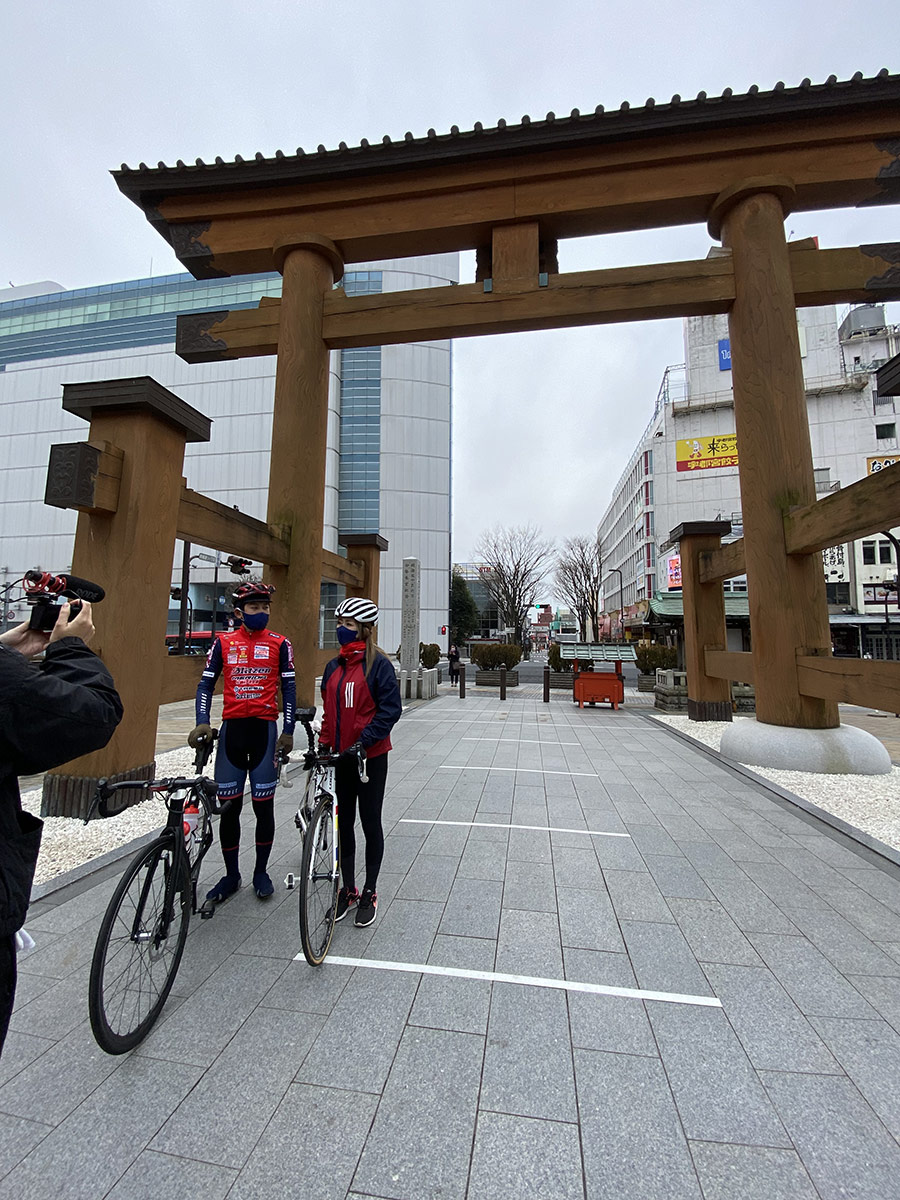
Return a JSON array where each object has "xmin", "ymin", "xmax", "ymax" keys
[{"xmin": 319, "ymin": 642, "xmax": 402, "ymax": 758}]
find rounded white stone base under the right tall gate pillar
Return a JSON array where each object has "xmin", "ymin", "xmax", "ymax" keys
[{"xmin": 719, "ymin": 718, "xmax": 890, "ymax": 775}]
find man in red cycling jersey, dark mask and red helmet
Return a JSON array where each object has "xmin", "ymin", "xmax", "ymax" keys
[{"xmin": 187, "ymin": 583, "xmax": 296, "ymax": 901}]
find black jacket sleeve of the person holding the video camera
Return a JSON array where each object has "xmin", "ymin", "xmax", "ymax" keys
[{"xmin": 0, "ymin": 637, "xmax": 122, "ymax": 775}]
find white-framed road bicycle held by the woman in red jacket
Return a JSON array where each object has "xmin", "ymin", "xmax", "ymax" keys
[{"xmin": 284, "ymin": 708, "xmax": 368, "ymax": 967}]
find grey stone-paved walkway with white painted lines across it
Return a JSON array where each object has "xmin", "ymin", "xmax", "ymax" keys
[{"xmin": 0, "ymin": 688, "xmax": 900, "ymax": 1200}]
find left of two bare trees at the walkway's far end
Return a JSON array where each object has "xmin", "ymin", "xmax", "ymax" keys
[{"xmin": 475, "ymin": 526, "xmax": 553, "ymax": 646}]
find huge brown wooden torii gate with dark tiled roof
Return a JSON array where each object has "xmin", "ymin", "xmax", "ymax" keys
[{"xmin": 98, "ymin": 72, "xmax": 900, "ymax": 758}]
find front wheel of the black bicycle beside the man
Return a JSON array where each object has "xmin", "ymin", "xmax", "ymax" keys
[{"xmin": 88, "ymin": 834, "xmax": 191, "ymax": 1054}]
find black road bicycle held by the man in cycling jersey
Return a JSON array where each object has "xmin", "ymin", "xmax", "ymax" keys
[{"xmin": 88, "ymin": 731, "xmax": 232, "ymax": 1054}]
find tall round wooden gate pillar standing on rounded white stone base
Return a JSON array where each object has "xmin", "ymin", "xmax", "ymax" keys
[{"xmin": 709, "ymin": 179, "xmax": 840, "ymax": 730}]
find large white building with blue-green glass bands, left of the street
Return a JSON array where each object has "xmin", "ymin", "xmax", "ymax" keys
[{"xmin": 0, "ymin": 254, "xmax": 458, "ymax": 652}]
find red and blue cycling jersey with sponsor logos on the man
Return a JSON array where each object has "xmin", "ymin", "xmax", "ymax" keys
[{"xmin": 197, "ymin": 625, "xmax": 296, "ymax": 733}]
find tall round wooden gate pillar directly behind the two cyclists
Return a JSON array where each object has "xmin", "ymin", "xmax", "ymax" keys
[{"xmin": 268, "ymin": 234, "xmax": 343, "ymax": 704}]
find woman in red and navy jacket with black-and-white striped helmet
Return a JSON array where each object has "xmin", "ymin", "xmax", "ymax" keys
[{"xmin": 319, "ymin": 596, "xmax": 402, "ymax": 925}]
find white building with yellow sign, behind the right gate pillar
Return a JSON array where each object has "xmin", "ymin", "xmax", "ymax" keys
[{"xmin": 600, "ymin": 298, "xmax": 900, "ymax": 659}]
